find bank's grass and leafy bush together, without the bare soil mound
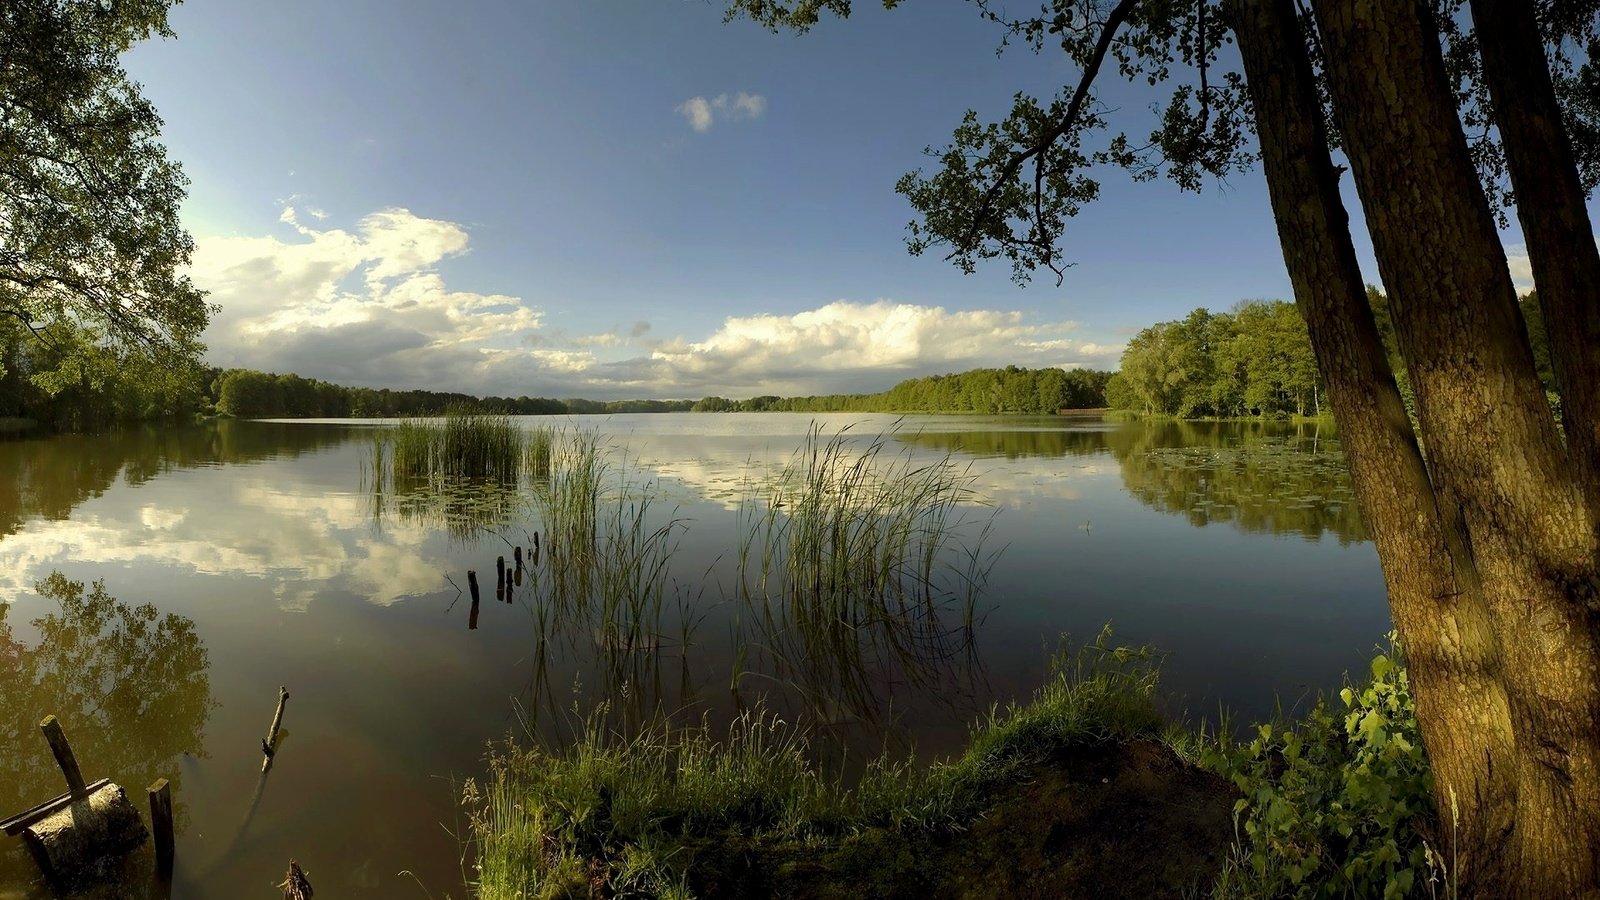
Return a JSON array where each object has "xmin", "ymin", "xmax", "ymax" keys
[{"xmin": 462, "ymin": 631, "xmax": 1454, "ymax": 900}]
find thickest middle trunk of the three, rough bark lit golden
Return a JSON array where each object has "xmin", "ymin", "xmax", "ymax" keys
[{"xmin": 1314, "ymin": 0, "xmax": 1600, "ymax": 897}]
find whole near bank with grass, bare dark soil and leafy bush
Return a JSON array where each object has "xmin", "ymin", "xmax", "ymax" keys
[{"xmin": 464, "ymin": 634, "xmax": 1448, "ymax": 900}]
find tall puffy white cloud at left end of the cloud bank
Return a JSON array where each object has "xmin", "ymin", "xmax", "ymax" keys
[{"xmin": 190, "ymin": 207, "xmax": 541, "ymax": 389}]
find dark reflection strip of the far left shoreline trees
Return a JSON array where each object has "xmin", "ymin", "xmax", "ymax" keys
[{"xmin": 0, "ymin": 421, "xmax": 350, "ymax": 536}]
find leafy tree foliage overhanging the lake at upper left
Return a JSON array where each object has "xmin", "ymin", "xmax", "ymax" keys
[{"xmin": 0, "ymin": 0, "xmax": 211, "ymax": 374}]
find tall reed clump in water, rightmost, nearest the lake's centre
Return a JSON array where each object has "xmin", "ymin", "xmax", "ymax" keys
[{"xmin": 733, "ymin": 424, "xmax": 994, "ymax": 717}]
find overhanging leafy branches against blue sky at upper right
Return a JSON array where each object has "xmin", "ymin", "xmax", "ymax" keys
[{"xmin": 726, "ymin": 0, "xmax": 1600, "ymax": 283}]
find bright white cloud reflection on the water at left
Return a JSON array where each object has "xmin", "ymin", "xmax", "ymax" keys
[{"xmin": 0, "ymin": 469, "xmax": 443, "ymax": 610}]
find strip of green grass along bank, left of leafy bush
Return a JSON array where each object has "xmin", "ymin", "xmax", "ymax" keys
[{"xmin": 464, "ymin": 633, "xmax": 1165, "ymax": 900}]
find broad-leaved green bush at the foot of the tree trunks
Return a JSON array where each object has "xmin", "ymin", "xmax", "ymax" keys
[{"xmin": 1203, "ymin": 634, "xmax": 1437, "ymax": 898}]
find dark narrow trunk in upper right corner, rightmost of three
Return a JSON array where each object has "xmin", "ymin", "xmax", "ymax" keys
[{"xmin": 1472, "ymin": 0, "xmax": 1600, "ymax": 514}]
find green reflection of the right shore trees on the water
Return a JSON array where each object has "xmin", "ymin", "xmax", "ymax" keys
[{"xmin": 899, "ymin": 421, "xmax": 1368, "ymax": 543}]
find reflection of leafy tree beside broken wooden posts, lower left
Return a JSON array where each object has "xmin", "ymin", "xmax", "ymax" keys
[{"xmin": 0, "ymin": 572, "xmax": 213, "ymax": 828}]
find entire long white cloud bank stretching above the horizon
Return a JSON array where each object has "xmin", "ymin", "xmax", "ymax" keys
[{"xmin": 190, "ymin": 207, "xmax": 1122, "ymax": 399}]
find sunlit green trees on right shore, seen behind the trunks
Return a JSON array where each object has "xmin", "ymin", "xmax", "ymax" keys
[{"xmin": 1106, "ymin": 294, "xmax": 1554, "ymax": 418}]
